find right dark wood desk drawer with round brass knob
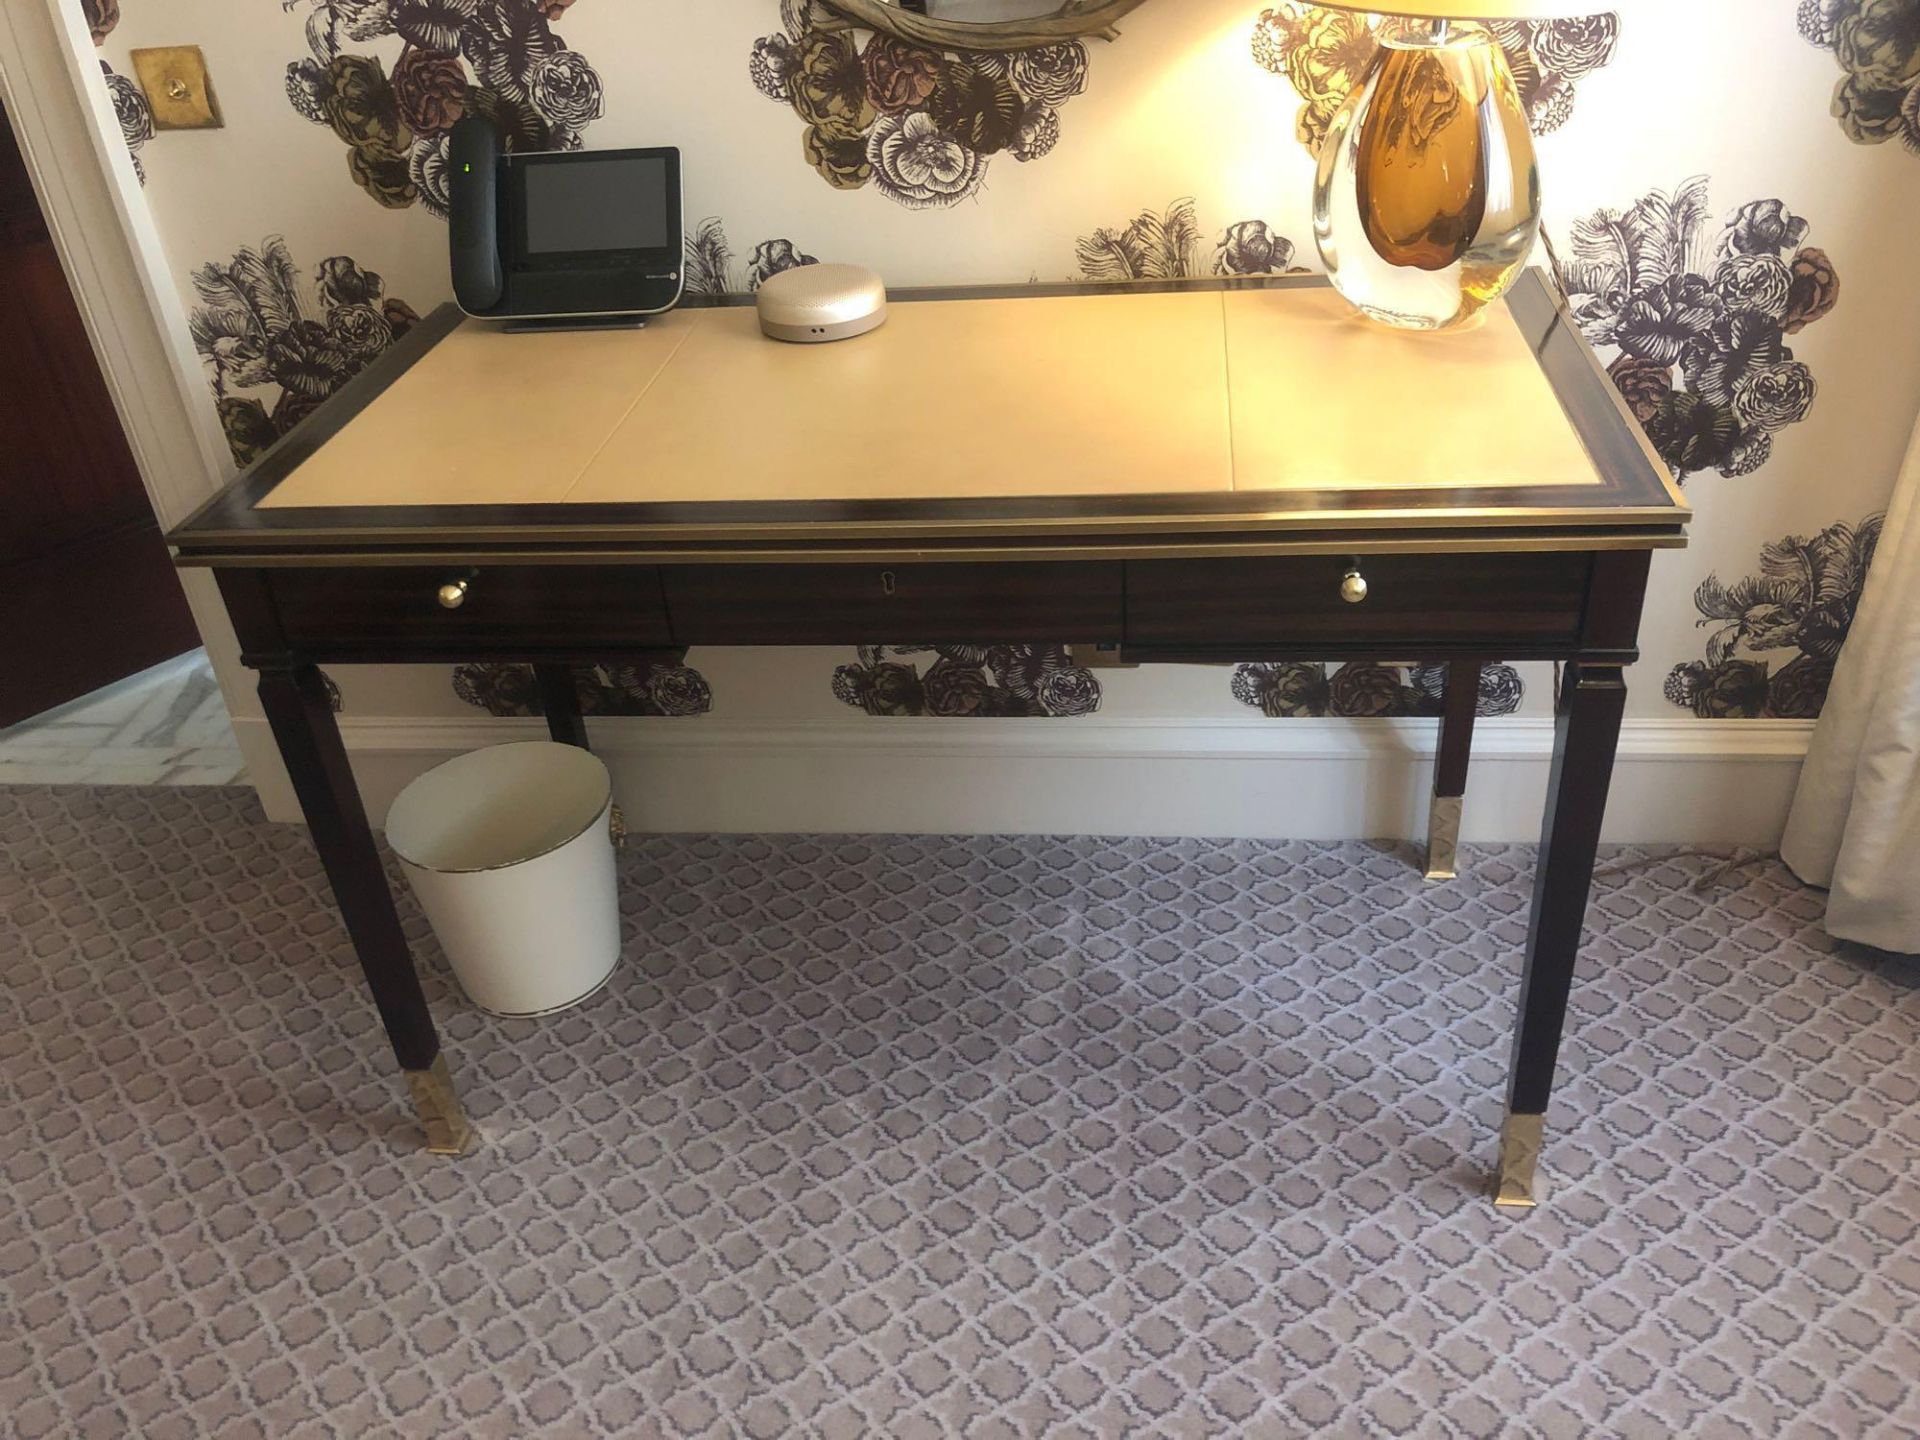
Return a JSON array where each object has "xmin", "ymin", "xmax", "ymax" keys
[{"xmin": 1127, "ymin": 553, "xmax": 1594, "ymax": 655}]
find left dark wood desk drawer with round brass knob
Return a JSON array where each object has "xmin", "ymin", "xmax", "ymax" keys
[{"xmin": 269, "ymin": 564, "xmax": 672, "ymax": 659}]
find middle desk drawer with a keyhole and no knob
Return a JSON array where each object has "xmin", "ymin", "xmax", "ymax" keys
[{"xmin": 662, "ymin": 563, "xmax": 1123, "ymax": 645}]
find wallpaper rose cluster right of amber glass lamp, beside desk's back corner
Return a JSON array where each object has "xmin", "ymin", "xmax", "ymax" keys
[{"xmin": 1567, "ymin": 175, "xmax": 1839, "ymax": 480}]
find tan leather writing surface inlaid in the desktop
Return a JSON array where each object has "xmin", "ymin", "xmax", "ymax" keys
[{"xmin": 261, "ymin": 288, "xmax": 1599, "ymax": 507}]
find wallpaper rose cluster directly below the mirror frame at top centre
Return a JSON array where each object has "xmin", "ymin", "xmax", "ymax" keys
[{"xmin": 747, "ymin": 0, "xmax": 1089, "ymax": 209}]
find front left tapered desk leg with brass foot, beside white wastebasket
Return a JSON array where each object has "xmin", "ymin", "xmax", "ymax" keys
[{"xmin": 259, "ymin": 664, "xmax": 474, "ymax": 1154}]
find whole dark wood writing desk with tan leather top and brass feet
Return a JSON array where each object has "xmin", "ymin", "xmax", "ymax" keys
[{"xmin": 171, "ymin": 273, "xmax": 1690, "ymax": 1204}]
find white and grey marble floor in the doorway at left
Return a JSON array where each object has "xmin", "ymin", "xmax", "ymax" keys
[{"xmin": 0, "ymin": 651, "xmax": 246, "ymax": 785}]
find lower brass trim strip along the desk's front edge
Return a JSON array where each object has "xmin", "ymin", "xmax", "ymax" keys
[{"xmin": 175, "ymin": 532, "xmax": 1688, "ymax": 570}]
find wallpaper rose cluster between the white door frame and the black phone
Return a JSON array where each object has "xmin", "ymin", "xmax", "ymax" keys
[{"xmin": 188, "ymin": 236, "xmax": 420, "ymax": 465}]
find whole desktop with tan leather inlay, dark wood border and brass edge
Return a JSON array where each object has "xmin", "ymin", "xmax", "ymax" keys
[{"xmin": 169, "ymin": 273, "xmax": 1690, "ymax": 564}]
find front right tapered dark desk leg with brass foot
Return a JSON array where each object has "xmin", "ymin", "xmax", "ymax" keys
[{"xmin": 1494, "ymin": 664, "xmax": 1626, "ymax": 1206}]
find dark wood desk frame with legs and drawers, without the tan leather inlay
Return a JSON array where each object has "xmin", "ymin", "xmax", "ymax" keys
[{"xmin": 171, "ymin": 273, "xmax": 1690, "ymax": 1204}]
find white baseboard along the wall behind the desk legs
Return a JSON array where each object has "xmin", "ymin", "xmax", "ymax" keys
[{"xmin": 238, "ymin": 716, "xmax": 1812, "ymax": 847}]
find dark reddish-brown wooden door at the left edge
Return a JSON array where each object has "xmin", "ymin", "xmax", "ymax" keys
[{"xmin": 0, "ymin": 96, "xmax": 200, "ymax": 726}]
